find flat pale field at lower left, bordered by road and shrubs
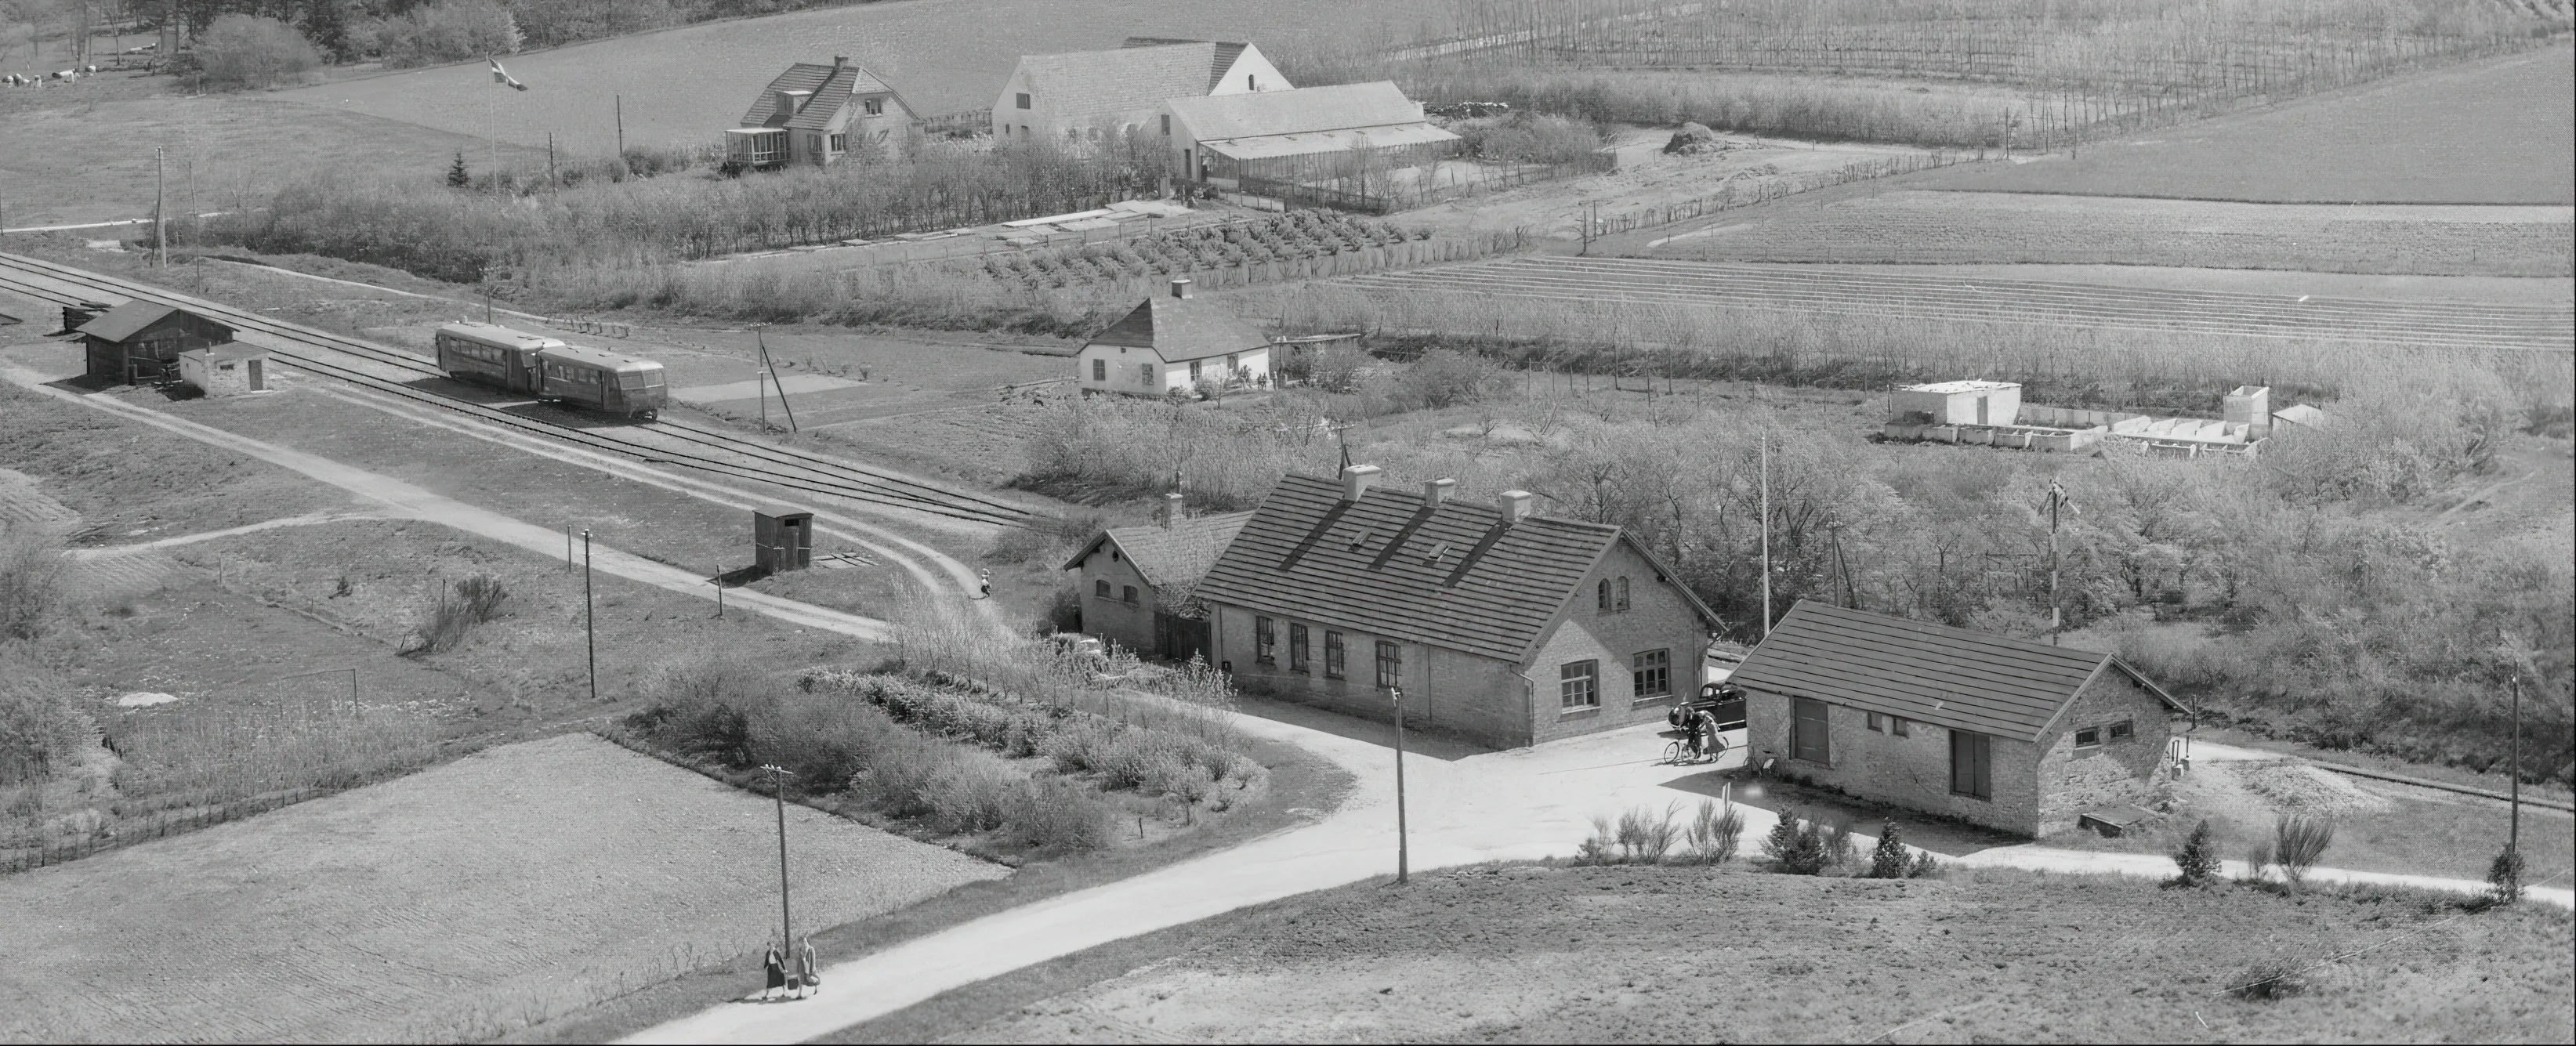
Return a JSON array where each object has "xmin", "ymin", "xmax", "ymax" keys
[{"xmin": 0, "ymin": 734, "xmax": 1005, "ymax": 1041}]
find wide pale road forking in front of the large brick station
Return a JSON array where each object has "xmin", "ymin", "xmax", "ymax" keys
[{"xmin": 623, "ymin": 698, "xmax": 2576, "ymax": 1044}]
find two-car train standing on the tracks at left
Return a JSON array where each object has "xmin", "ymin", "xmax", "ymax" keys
[{"xmin": 433, "ymin": 322, "xmax": 670, "ymax": 418}]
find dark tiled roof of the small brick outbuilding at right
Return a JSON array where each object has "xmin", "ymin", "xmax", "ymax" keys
[{"xmin": 1729, "ymin": 600, "xmax": 2182, "ymax": 742}]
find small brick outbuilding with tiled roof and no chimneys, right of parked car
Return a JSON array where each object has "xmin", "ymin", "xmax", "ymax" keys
[{"xmin": 1729, "ymin": 603, "xmax": 2182, "ymax": 834}]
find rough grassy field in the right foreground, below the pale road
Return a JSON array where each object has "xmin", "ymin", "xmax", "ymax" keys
[{"xmin": 940, "ymin": 866, "xmax": 2576, "ymax": 1044}]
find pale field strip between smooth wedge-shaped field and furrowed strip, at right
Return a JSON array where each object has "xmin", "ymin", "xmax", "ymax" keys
[{"xmin": 1595, "ymin": 188, "xmax": 2576, "ymax": 276}]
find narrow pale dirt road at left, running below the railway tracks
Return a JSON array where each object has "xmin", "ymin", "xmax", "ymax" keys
[{"xmin": 0, "ymin": 366, "xmax": 886, "ymax": 639}]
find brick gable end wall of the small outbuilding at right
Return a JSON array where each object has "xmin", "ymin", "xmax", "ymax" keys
[{"xmin": 2038, "ymin": 670, "xmax": 2172, "ymax": 834}]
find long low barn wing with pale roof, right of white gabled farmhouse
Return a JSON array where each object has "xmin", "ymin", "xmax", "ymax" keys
[{"xmin": 1161, "ymin": 80, "xmax": 1461, "ymax": 188}]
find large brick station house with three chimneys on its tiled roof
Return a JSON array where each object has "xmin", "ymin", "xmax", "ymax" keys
[{"xmin": 1197, "ymin": 464, "xmax": 1718, "ymax": 747}]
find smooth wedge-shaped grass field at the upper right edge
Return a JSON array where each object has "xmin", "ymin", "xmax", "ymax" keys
[{"xmin": 1914, "ymin": 42, "xmax": 2576, "ymax": 204}]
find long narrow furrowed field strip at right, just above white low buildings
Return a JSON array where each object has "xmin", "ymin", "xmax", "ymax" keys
[{"xmin": 1339, "ymin": 258, "xmax": 2576, "ymax": 353}]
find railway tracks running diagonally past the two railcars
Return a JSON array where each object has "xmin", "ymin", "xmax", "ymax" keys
[{"xmin": 0, "ymin": 255, "xmax": 1035, "ymax": 526}]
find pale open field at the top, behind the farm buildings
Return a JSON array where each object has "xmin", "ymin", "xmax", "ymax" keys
[{"xmin": 278, "ymin": 0, "xmax": 1445, "ymax": 154}]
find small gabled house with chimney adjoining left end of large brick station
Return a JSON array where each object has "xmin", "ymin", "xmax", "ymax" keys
[{"xmin": 1061, "ymin": 494, "xmax": 1252, "ymax": 662}]
